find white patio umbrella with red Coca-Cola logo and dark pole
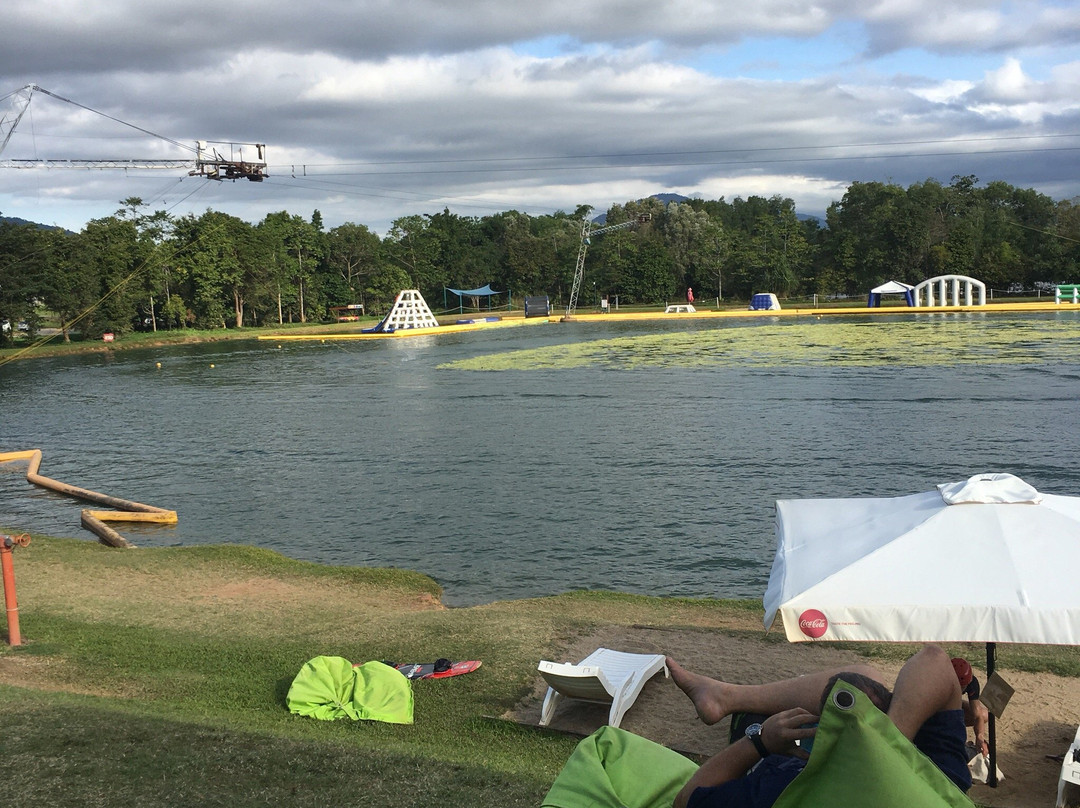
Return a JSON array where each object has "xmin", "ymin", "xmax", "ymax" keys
[{"xmin": 765, "ymin": 473, "xmax": 1080, "ymax": 785}]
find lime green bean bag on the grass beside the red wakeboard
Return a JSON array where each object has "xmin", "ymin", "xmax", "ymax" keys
[{"xmin": 285, "ymin": 657, "xmax": 413, "ymax": 724}]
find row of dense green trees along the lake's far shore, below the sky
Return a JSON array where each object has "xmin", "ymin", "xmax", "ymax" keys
[{"xmin": 0, "ymin": 176, "xmax": 1080, "ymax": 345}]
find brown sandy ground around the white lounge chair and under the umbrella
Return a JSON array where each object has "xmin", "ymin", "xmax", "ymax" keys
[{"xmin": 507, "ymin": 628, "xmax": 1080, "ymax": 808}]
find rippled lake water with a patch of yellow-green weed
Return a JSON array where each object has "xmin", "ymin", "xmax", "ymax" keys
[{"xmin": 0, "ymin": 311, "xmax": 1080, "ymax": 605}]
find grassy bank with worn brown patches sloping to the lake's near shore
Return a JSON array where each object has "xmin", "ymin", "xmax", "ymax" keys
[{"xmin": 0, "ymin": 537, "xmax": 1080, "ymax": 808}]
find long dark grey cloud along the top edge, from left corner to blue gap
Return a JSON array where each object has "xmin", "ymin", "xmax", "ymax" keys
[{"xmin": 0, "ymin": 0, "xmax": 816, "ymax": 75}]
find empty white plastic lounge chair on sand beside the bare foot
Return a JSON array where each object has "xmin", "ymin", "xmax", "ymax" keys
[{"xmin": 538, "ymin": 648, "xmax": 670, "ymax": 727}]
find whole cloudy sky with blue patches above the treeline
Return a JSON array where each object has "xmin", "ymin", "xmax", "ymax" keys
[{"xmin": 0, "ymin": 0, "xmax": 1080, "ymax": 233}]
